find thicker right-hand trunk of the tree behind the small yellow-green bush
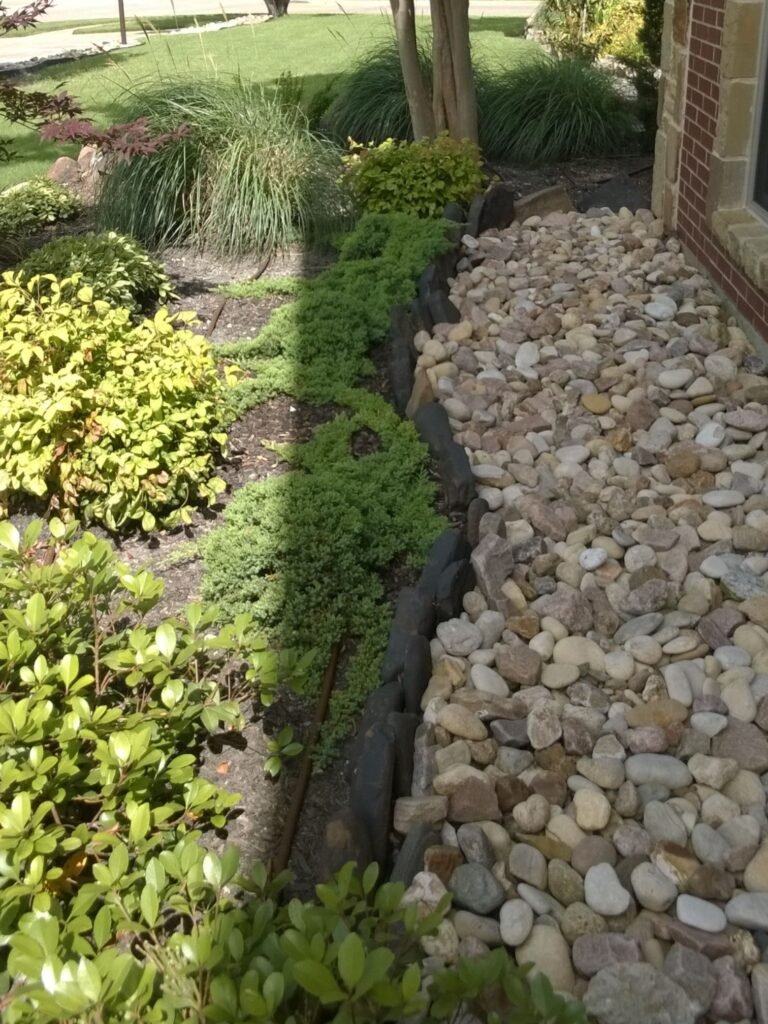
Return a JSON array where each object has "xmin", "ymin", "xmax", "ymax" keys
[{"xmin": 430, "ymin": 0, "xmax": 477, "ymax": 142}]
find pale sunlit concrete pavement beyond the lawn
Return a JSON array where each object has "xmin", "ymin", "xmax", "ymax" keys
[{"xmin": 0, "ymin": 0, "xmax": 539, "ymax": 67}]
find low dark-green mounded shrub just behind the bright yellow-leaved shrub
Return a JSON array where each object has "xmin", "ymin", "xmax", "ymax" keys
[{"xmin": 16, "ymin": 231, "xmax": 173, "ymax": 312}]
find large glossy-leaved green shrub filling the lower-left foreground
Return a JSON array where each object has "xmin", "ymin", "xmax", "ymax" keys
[{"xmin": 0, "ymin": 519, "xmax": 586, "ymax": 1024}]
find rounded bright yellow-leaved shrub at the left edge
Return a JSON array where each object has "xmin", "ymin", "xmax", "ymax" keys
[{"xmin": 0, "ymin": 273, "xmax": 226, "ymax": 529}]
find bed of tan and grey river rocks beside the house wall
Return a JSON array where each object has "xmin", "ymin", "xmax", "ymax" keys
[{"xmin": 394, "ymin": 210, "xmax": 768, "ymax": 1024}]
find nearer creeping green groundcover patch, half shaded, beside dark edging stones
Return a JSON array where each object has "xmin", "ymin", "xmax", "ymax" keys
[{"xmin": 204, "ymin": 389, "xmax": 443, "ymax": 767}]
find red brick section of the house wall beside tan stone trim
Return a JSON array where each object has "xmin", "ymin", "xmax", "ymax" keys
[{"xmin": 656, "ymin": 0, "xmax": 768, "ymax": 340}]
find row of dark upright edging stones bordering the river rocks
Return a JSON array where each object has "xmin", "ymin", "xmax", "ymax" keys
[{"xmin": 324, "ymin": 182, "xmax": 562, "ymax": 884}]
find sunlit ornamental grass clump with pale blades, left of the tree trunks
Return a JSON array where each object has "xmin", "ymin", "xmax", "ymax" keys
[{"xmin": 97, "ymin": 78, "xmax": 347, "ymax": 256}]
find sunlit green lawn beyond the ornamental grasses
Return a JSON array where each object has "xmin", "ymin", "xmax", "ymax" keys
[{"xmin": 0, "ymin": 14, "xmax": 538, "ymax": 187}]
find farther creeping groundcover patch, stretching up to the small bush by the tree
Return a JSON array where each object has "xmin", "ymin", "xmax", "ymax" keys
[{"xmin": 218, "ymin": 213, "xmax": 451, "ymax": 416}]
